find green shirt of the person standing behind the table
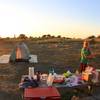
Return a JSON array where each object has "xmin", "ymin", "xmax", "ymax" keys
[{"xmin": 81, "ymin": 48, "xmax": 91, "ymax": 64}]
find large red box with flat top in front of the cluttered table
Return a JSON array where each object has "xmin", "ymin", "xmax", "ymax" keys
[{"xmin": 24, "ymin": 87, "xmax": 61, "ymax": 100}]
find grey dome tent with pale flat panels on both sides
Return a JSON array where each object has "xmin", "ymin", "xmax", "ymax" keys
[{"xmin": 0, "ymin": 43, "xmax": 38, "ymax": 64}]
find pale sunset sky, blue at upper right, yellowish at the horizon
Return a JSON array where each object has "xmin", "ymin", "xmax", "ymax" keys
[{"xmin": 0, "ymin": 0, "xmax": 100, "ymax": 38}]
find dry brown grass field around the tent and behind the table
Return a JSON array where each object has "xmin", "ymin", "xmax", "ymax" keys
[{"xmin": 0, "ymin": 39, "xmax": 100, "ymax": 100}]
